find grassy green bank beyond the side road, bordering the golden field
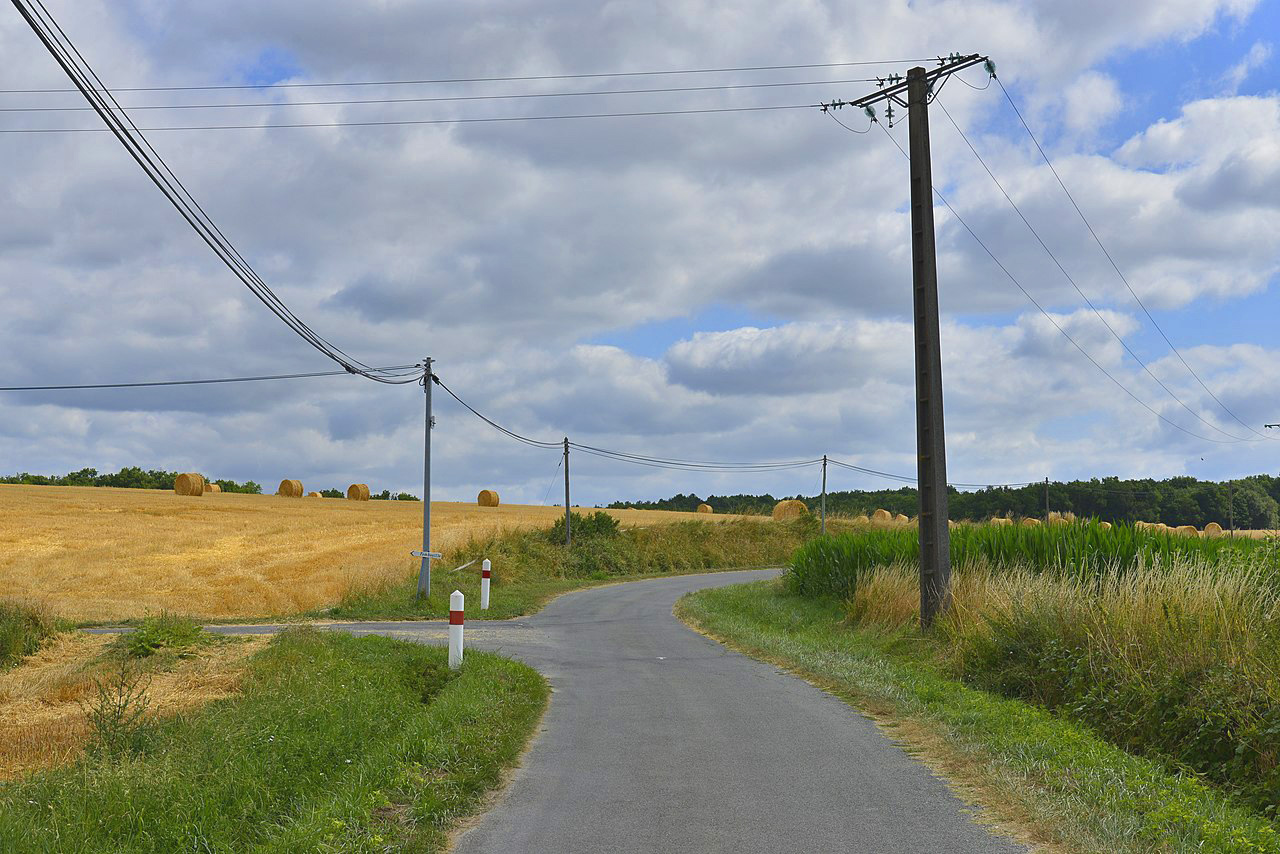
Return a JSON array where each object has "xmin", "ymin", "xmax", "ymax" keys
[{"xmin": 322, "ymin": 513, "xmax": 818, "ymax": 620}]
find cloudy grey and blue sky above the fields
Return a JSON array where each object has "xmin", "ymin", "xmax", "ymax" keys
[{"xmin": 0, "ymin": 0, "xmax": 1280, "ymax": 504}]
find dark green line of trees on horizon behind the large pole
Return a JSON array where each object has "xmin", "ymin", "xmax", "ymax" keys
[{"xmin": 609, "ymin": 475, "xmax": 1280, "ymax": 529}]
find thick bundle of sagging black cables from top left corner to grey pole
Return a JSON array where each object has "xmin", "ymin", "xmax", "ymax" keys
[{"xmin": 13, "ymin": 0, "xmax": 416, "ymax": 384}]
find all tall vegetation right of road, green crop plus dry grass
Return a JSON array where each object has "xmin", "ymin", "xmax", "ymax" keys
[{"xmin": 787, "ymin": 522, "xmax": 1280, "ymax": 818}]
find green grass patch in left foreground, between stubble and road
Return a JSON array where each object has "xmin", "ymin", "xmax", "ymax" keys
[{"xmin": 0, "ymin": 629, "xmax": 548, "ymax": 854}]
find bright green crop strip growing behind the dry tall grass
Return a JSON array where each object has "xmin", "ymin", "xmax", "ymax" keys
[{"xmin": 788, "ymin": 521, "xmax": 1280, "ymax": 597}]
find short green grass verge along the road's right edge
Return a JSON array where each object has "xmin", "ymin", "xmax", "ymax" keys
[{"xmin": 677, "ymin": 583, "xmax": 1280, "ymax": 854}]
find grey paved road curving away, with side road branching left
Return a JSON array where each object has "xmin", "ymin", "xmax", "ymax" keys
[{"xmin": 120, "ymin": 571, "xmax": 1025, "ymax": 854}]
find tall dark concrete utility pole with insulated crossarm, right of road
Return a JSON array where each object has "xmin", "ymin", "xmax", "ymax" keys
[{"xmin": 819, "ymin": 54, "xmax": 995, "ymax": 629}]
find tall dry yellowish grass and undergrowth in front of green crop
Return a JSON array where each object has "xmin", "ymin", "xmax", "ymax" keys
[{"xmin": 845, "ymin": 557, "xmax": 1280, "ymax": 818}]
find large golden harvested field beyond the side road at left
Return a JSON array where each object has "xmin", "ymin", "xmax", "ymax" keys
[{"xmin": 0, "ymin": 484, "xmax": 747, "ymax": 621}]
